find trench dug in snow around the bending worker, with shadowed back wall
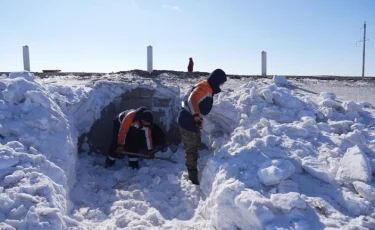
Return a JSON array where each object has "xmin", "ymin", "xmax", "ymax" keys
[{"xmin": 71, "ymin": 87, "xmax": 226, "ymax": 228}]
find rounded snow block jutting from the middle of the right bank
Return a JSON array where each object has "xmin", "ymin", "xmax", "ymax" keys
[{"xmin": 258, "ymin": 159, "xmax": 295, "ymax": 186}]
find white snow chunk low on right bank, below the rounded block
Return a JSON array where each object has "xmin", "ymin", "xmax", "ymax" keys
[{"xmin": 271, "ymin": 192, "xmax": 306, "ymax": 213}]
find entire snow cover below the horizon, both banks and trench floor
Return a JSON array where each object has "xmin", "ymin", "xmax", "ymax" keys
[{"xmin": 0, "ymin": 73, "xmax": 375, "ymax": 230}]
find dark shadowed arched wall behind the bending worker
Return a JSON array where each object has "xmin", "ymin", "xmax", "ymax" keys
[{"xmin": 79, "ymin": 86, "xmax": 181, "ymax": 154}]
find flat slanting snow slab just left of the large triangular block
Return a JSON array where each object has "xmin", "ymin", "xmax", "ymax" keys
[{"xmin": 302, "ymin": 156, "xmax": 334, "ymax": 183}]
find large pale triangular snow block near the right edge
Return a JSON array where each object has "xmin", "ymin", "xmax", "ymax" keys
[{"xmin": 336, "ymin": 146, "xmax": 372, "ymax": 182}]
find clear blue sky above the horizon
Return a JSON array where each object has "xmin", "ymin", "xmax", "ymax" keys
[{"xmin": 0, "ymin": 0, "xmax": 375, "ymax": 76}]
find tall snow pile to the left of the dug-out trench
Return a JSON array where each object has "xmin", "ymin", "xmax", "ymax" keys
[{"xmin": 0, "ymin": 72, "xmax": 77, "ymax": 229}]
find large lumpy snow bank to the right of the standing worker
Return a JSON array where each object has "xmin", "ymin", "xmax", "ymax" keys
[{"xmin": 198, "ymin": 83, "xmax": 375, "ymax": 229}]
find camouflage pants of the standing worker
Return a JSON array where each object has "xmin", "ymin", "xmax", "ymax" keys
[{"xmin": 180, "ymin": 126, "xmax": 201, "ymax": 169}]
